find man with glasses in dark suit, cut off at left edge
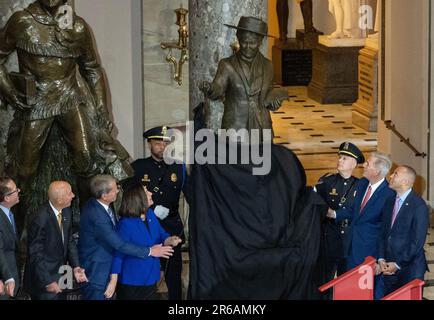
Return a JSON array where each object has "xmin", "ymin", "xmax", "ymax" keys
[{"xmin": 0, "ymin": 177, "xmax": 20, "ymax": 300}]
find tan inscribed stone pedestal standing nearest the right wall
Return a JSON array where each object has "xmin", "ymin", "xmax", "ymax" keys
[{"xmin": 353, "ymin": 41, "xmax": 378, "ymax": 131}]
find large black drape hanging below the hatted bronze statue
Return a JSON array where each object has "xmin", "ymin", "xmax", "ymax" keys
[{"xmin": 189, "ymin": 105, "xmax": 327, "ymax": 300}]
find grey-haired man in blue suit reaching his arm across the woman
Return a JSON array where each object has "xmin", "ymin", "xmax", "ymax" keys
[{"xmin": 78, "ymin": 175, "xmax": 173, "ymax": 300}]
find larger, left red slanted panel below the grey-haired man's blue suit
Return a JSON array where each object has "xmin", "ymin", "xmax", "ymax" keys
[{"xmin": 319, "ymin": 257, "xmax": 376, "ymax": 300}]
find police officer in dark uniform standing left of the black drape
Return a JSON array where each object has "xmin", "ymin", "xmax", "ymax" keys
[{"xmin": 131, "ymin": 127, "xmax": 187, "ymax": 300}]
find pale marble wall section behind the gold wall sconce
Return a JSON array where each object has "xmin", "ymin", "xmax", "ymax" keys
[{"xmin": 142, "ymin": 0, "xmax": 190, "ymax": 156}]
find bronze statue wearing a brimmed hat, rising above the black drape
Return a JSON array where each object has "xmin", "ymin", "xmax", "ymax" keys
[{"xmin": 200, "ymin": 17, "xmax": 288, "ymax": 136}]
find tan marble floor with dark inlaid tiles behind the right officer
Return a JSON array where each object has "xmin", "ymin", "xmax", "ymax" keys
[{"xmin": 158, "ymin": 87, "xmax": 434, "ymax": 300}]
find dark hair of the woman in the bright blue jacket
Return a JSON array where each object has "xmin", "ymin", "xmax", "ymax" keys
[{"xmin": 119, "ymin": 184, "xmax": 149, "ymax": 218}]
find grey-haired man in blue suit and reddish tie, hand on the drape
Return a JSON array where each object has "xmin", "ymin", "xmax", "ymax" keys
[{"xmin": 327, "ymin": 152, "xmax": 395, "ymax": 299}]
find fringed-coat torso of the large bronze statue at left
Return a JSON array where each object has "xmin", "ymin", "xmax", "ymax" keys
[{"xmin": 5, "ymin": 2, "xmax": 93, "ymax": 120}]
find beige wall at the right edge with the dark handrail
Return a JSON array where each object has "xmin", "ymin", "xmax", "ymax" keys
[{"xmin": 378, "ymin": 0, "xmax": 428, "ymax": 198}]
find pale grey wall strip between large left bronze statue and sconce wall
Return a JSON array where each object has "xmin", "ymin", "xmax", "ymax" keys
[{"xmin": 75, "ymin": 0, "xmax": 143, "ymax": 158}]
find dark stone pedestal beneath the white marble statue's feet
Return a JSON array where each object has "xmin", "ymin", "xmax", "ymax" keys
[{"xmin": 307, "ymin": 36, "xmax": 363, "ymax": 104}]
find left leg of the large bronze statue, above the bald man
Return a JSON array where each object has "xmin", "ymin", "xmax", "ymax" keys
[{"xmin": 17, "ymin": 118, "xmax": 54, "ymax": 192}]
